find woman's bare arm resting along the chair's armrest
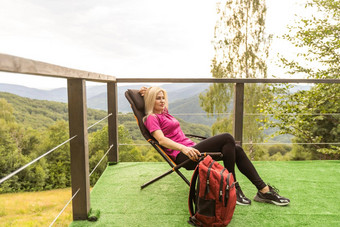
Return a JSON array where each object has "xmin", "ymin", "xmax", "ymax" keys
[{"xmin": 151, "ymin": 130, "xmax": 201, "ymax": 161}]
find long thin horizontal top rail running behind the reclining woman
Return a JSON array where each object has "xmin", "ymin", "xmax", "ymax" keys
[{"xmin": 116, "ymin": 76, "xmax": 340, "ymax": 84}]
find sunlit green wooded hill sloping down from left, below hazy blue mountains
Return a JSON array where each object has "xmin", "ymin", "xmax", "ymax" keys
[{"xmin": 0, "ymin": 92, "xmax": 211, "ymax": 141}]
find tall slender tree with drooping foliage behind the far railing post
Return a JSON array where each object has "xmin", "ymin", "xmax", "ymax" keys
[{"xmin": 200, "ymin": 0, "xmax": 270, "ymax": 156}]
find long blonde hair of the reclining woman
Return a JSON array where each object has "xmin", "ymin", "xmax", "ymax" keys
[{"xmin": 143, "ymin": 87, "xmax": 168, "ymax": 121}]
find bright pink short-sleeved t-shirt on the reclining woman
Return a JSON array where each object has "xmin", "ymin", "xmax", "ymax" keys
[{"xmin": 144, "ymin": 109, "xmax": 195, "ymax": 160}]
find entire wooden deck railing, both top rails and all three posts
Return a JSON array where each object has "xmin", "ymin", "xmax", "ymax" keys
[{"xmin": 0, "ymin": 54, "xmax": 340, "ymax": 220}]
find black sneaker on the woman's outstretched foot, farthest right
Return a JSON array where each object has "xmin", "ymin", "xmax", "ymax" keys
[{"xmin": 254, "ymin": 185, "xmax": 290, "ymax": 206}]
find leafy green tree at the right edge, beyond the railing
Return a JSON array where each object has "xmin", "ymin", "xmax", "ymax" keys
[{"xmin": 259, "ymin": 0, "xmax": 340, "ymax": 159}]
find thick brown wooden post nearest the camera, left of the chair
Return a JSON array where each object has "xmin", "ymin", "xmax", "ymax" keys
[{"xmin": 67, "ymin": 79, "xmax": 90, "ymax": 220}]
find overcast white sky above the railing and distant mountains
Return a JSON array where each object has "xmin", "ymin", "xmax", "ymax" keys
[{"xmin": 0, "ymin": 0, "xmax": 304, "ymax": 89}]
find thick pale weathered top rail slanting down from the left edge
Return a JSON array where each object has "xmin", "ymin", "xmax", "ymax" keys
[{"xmin": 0, "ymin": 54, "xmax": 116, "ymax": 82}]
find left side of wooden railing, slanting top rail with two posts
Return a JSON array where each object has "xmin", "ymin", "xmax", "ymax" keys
[{"xmin": 0, "ymin": 54, "xmax": 118, "ymax": 220}]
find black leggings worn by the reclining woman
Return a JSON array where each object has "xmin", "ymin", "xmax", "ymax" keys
[{"xmin": 175, "ymin": 133, "xmax": 266, "ymax": 190}]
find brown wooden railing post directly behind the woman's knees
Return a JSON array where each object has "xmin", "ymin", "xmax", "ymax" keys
[{"xmin": 233, "ymin": 83, "xmax": 244, "ymax": 146}]
